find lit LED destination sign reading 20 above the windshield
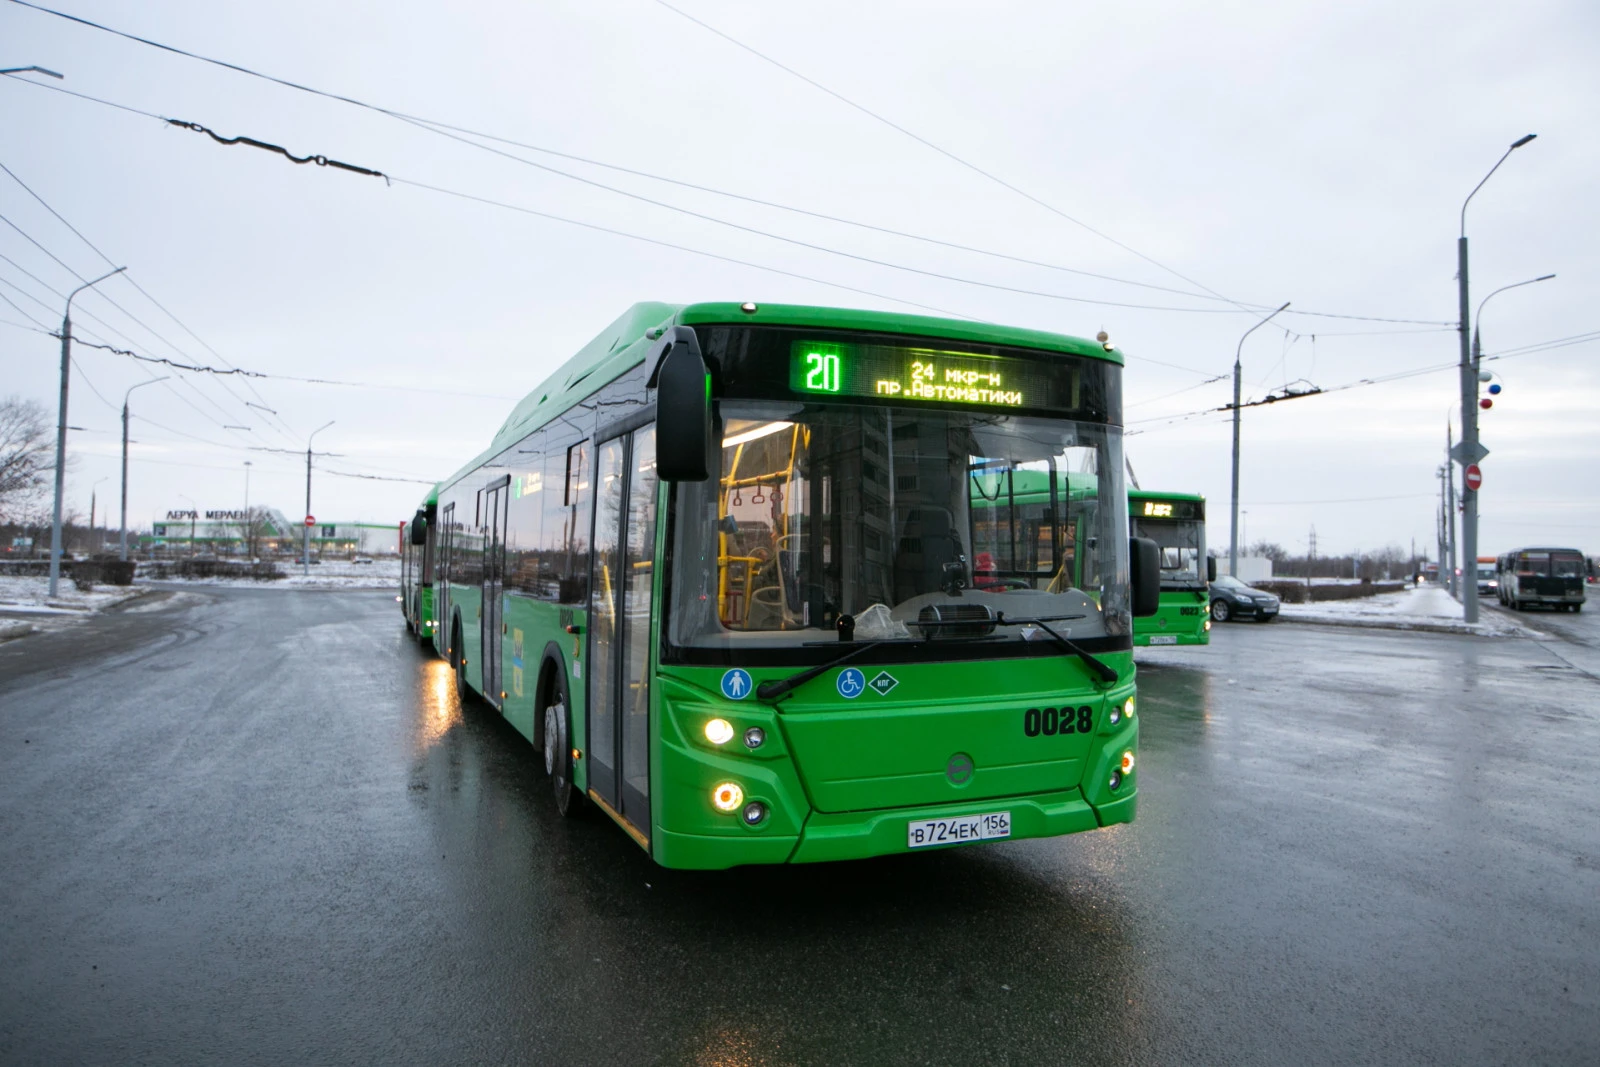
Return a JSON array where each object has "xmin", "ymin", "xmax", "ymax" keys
[{"xmin": 789, "ymin": 341, "xmax": 1078, "ymax": 408}]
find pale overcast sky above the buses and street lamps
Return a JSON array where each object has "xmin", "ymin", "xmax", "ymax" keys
[{"xmin": 0, "ymin": 0, "xmax": 1600, "ymax": 555}]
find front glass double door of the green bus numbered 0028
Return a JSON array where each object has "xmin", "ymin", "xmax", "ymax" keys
[{"xmin": 587, "ymin": 426, "xmax": 656, "ymax": 848}]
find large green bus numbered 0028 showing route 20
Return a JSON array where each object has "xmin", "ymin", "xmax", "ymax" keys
[{"xmin": 413, "ymin": 304, "xmax": 1160, "ymax": 869}]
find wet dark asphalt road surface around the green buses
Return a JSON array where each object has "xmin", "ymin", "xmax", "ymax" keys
[{"xmin": 0, "ymin": 590, "xmax": 1600, "ymax": 1065}]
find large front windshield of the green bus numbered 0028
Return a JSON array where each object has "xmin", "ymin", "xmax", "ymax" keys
[{"xmin": 667, "ymin": 402, "xmax": 1131, "ymax": 662}]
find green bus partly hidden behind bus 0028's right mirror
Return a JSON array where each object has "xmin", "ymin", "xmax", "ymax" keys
[{"xmin": 1128, "ymin": 490, "xmax": 1216, "ymax": 645}]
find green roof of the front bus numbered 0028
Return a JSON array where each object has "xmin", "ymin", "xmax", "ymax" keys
[{"xmin": 429, "ymin": 302, "xmax": 1123, "ymax": 502}]
